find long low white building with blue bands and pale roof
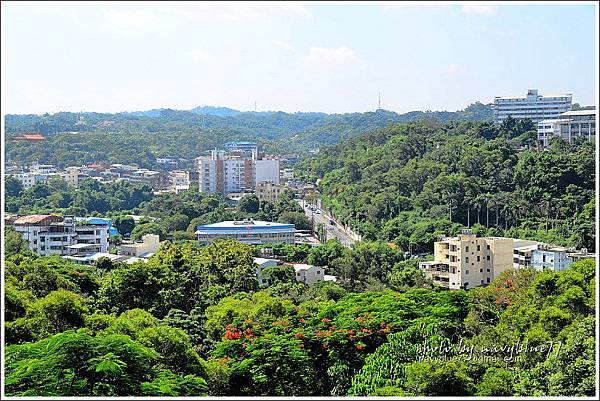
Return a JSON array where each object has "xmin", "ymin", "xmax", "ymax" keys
[{"xmin": 195, "ymin": 220, "xmax": 296, "ymax": 245}]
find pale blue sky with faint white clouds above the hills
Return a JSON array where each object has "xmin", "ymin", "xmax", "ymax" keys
[{"xmin": 2, "ymin": 2, "xmax": 597, "ymax": 113}]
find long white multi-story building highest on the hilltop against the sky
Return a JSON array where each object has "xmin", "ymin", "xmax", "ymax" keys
[{"xmin": 494, "ymin": 89, "xmax": 572, "ymax": 124}]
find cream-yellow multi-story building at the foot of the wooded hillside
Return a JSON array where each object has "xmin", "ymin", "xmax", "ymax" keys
[{"xmin": 419, "ymin": 230, "xmax": 513, "ymax": 290}]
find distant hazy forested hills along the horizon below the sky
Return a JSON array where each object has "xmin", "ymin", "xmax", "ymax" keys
[{"xmin": 5, "ymin": 103, "xmax": 492, "ymax": 167}]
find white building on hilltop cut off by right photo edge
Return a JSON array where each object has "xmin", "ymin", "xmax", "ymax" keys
[{"xmin": 537, "ymin": 110, "xmax": 596, "ymax": 148}]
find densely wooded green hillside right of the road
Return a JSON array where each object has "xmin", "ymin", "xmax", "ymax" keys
[{"xmin": 297, "ymin": 118, "xmax": 596, "ymax": 252}]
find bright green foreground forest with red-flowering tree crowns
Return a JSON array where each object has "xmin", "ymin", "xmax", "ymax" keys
[{"xmin": 4, "ymin": 233, "xmax": 596, "ymax": 397}]
